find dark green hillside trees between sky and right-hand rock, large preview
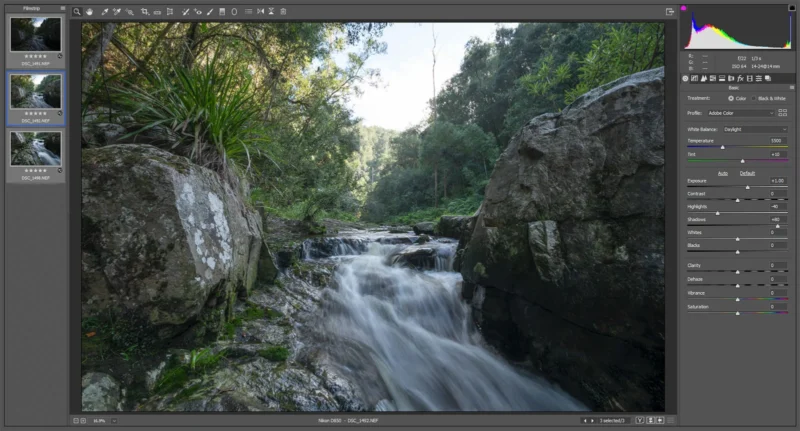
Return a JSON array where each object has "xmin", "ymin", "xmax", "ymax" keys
[{"xmin": 362, "ymin": 23, "xmax": 664, "ymax": 224}]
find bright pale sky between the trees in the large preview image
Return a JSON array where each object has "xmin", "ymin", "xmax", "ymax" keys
[{"xmin": 338, "ymin": 23, "xmax": 516, "ymax": 130}]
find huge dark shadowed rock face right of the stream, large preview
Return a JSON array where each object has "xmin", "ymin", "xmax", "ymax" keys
[{"xmin": 458, "ymin": 69, "xmax": 664, "ymax": 411}]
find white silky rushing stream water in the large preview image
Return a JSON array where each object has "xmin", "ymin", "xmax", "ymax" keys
[{"xmin": 320, "ymin": 238, "xmax": 587, "ymax": 411}]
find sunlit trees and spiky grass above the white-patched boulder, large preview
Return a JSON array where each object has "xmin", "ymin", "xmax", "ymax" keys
[{"xmin": 81, "ymin": 22, "xmax": 386, "ymax": 211}]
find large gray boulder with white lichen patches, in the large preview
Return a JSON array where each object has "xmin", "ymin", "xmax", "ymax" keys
[{"xmin": 81, "ymin": 145, "xmax": 262, "ymax": 341}]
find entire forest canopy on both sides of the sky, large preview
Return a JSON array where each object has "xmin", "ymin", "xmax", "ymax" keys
[{"xmin": 82, "ymin": 23, "xmax": 664, "ymax": 223}]
